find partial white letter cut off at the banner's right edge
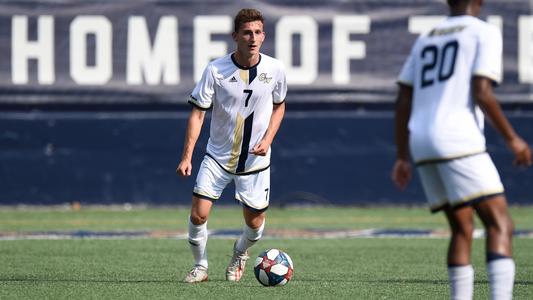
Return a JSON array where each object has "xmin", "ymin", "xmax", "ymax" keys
[{"xmin": 518, "ymin": 16, "xmax": 533, "ymax": 84}]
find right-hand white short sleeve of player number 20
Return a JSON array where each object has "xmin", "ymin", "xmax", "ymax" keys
[{"xmin": 473, "ymin": 25, "xmax": 503, "ymax": 84}]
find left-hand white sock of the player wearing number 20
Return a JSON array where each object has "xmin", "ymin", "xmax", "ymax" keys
[{"xmin": 448, "ymin": 265, "xmax": 474, "ymax": 300}]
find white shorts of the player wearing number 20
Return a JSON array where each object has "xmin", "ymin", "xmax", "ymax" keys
[{"xmin": 417, "ymin": 153, "xmax": 504, "ymax": 212}]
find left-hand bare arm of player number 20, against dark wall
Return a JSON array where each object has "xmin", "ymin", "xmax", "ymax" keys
[{"xmin": 392, "ymin": 83, "xmax": 413, "ymax": 189}]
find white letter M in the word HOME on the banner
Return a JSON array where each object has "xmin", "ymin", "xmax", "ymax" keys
[{"xmin": 126, "ymin": 16, "xmax": 179, "ymax": 85}]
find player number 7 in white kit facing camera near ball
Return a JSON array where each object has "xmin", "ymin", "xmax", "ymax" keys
[{"xmin": 176, "ymin": 9, "xmax": 287, "ymax": 283}]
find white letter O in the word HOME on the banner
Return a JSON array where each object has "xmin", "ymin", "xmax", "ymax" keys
[{"xmin": 70, "ymin": 16, "xmax": 113, "ymax": 85}]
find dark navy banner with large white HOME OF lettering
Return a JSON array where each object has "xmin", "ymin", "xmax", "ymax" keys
[{"xmin": 0, "ymin": 0, "xmax": 533, "ymax": 105}]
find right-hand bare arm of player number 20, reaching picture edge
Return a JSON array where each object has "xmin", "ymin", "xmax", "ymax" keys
[{"xmin": 472, "ymin": 76, "xmax": 532, "ymax": 166}]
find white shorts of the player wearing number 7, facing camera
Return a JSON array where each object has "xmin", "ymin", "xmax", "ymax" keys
[{"xmin": 193, "ymin": 155, "xmax": 270, "ymax": 210}]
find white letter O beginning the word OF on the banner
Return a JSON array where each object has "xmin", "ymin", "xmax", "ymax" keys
[{"xmin": 276, "ymin": 16, "xmax": 318, "ymax": 84}]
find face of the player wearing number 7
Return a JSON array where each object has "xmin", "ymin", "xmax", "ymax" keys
[{"xmin": 233, "ymin": 21, "xmax": 265, "ymax": 57}]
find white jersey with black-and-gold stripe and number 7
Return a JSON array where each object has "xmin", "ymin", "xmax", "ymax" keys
[{"xmin": 189, "ymin": 54, "xmax": 287, "ymax": 174}]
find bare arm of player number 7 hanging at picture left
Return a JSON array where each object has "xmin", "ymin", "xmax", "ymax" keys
[{"xmin": 176, "ymin": 106, "xmax": 205, "ymax": 176}]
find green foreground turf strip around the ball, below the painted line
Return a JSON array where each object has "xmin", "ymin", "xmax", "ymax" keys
[{"xmin": 0, "ymin": 238, "xmax": 533, "ymax": 299}]
